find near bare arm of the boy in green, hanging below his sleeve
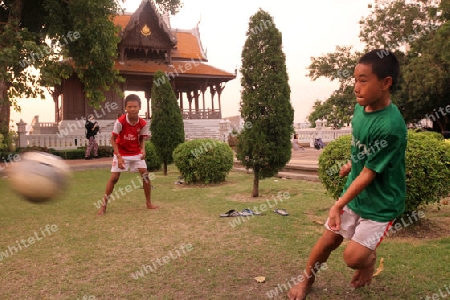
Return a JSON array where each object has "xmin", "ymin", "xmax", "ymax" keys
[{"xmin": 328, "ymin": 167, "xmax": 377, "ymax": 230}]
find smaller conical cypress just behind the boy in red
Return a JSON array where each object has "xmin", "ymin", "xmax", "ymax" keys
[{"xmin": 150, "ymin": 71, "xmax": 184, "ymax": 175}]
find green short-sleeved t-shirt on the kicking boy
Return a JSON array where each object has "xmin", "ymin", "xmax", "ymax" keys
[{"xmin": 341, "ymin": 103, "xmax": 407, "ymax": 222}]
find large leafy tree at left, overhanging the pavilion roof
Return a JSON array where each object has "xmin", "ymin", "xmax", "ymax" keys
[{"xmin": 0, "ymin": 0, "xmax": 181, "ymax": 148}]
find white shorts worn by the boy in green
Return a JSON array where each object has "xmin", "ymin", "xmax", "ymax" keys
[{"xmin": 325, "ymin": 205, "xmax": 394, "ymax": 250}]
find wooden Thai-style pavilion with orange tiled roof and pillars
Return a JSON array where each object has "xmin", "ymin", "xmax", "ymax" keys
[{"xmin": 52, "ymin": 0, "xmax": 236, "ymax": 138}]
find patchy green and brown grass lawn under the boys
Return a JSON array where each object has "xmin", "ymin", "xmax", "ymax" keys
[{"xmin": 0, "ymin": 166, "xmax": 450, "ymax": 300}]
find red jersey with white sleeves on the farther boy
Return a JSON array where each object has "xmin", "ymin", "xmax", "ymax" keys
[{"xmin": 112, "ymin": 114, "xmax": 148, "ymax": 156}]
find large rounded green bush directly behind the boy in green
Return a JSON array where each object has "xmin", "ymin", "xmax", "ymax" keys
[{"xmin": 319, "ymin": 130, "xmax": 450, "ymax": 215}]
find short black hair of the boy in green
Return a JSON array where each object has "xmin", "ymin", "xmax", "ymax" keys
[{"xmin": 358, "ymin": 49, "xmax": 400, "ymax": 92}]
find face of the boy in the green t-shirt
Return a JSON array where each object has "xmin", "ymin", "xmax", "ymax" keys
[{"xmin": 354, "ymin": 64, "xmax": 392, "ymax": 106}]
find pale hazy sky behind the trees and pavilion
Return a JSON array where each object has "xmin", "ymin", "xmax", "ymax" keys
[{"xmin": 11, "ymin": 0, "xmax": 373, "ymax": 124}]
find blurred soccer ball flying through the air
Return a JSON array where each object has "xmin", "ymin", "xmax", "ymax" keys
[{"xmin": 7, "ymin": 152, "xmax": 70, "ymax": 202}]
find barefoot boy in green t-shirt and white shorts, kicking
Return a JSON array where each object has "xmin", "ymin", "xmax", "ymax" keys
[{"xmin": 288, "ymin": 49, "xmax": 407, "ymax": 300}]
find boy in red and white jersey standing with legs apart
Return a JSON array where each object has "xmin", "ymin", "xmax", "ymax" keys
[{"xmin": 97, "ymin": 94, "xmax": 158, "ymax": 215}]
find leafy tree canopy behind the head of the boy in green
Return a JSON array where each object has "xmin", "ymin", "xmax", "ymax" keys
[{"xmin": 308, "ymin": 0, "xmax": 450, "ymax": 131}]
